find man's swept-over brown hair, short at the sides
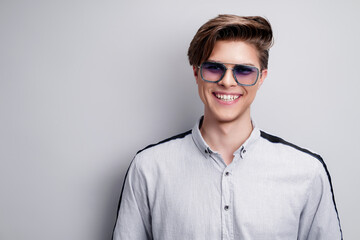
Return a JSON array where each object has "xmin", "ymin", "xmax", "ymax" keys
[{"xmin": 188, "ymin": 14, "xmax": 273, "ymax": 70}]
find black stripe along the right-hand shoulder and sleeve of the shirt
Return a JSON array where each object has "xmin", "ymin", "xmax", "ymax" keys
[{"xmin": 260, "ymin": 131, "xmax": 343, "ymax": 239}]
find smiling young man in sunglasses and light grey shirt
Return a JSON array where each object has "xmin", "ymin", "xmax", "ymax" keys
[{"xmin": 113, "ymin": 15, "xmax": 342, "ymax": 240}]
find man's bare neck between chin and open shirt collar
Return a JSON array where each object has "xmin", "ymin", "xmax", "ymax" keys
[{"xmin": 200, "ymin": 113, "xmax": 253, "ymax": 164}]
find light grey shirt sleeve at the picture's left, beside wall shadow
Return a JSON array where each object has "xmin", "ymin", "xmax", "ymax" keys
[{"xmin": 113, "ymin": 157, "xmax": 152, "ymax": 240}]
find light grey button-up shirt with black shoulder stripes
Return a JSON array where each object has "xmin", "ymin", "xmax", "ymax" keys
[{"xmin": 113, "ymin": 120, "xmax": 342, "ymax": 240}]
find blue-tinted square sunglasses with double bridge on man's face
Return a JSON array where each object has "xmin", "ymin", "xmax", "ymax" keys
[{"xmin": 198, "ymin": 62, "xmax": 259, "ymax": 86}]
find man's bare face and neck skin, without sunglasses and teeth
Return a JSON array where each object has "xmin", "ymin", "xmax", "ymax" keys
[{"xmin": 193, "ymin": 40, "xmax": 267, "ymax": 164}]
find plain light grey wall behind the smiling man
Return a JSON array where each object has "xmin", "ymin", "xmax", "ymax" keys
[{"xmin": 0, "ymin": 0, "xmax": 360, "ymax": 240}]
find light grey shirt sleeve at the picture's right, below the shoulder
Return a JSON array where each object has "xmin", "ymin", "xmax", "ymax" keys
[{"xmin": 298, "ymin": 162, "xmax": 342, "ymax": 240}]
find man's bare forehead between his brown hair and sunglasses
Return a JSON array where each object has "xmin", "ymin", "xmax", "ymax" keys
[{"xmin": 208, "ymin": 40, "xmax": 260, "ymax": 67}]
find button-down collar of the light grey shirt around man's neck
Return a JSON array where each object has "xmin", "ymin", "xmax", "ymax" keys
[{"xmin": 192, "ymin": 116, "xmax": 260, "ymax": 157}]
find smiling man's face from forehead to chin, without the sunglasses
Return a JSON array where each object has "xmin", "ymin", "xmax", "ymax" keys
[{"xmin": 193, "ymin": 40, "xmax": 267, "ymax": 122}]
